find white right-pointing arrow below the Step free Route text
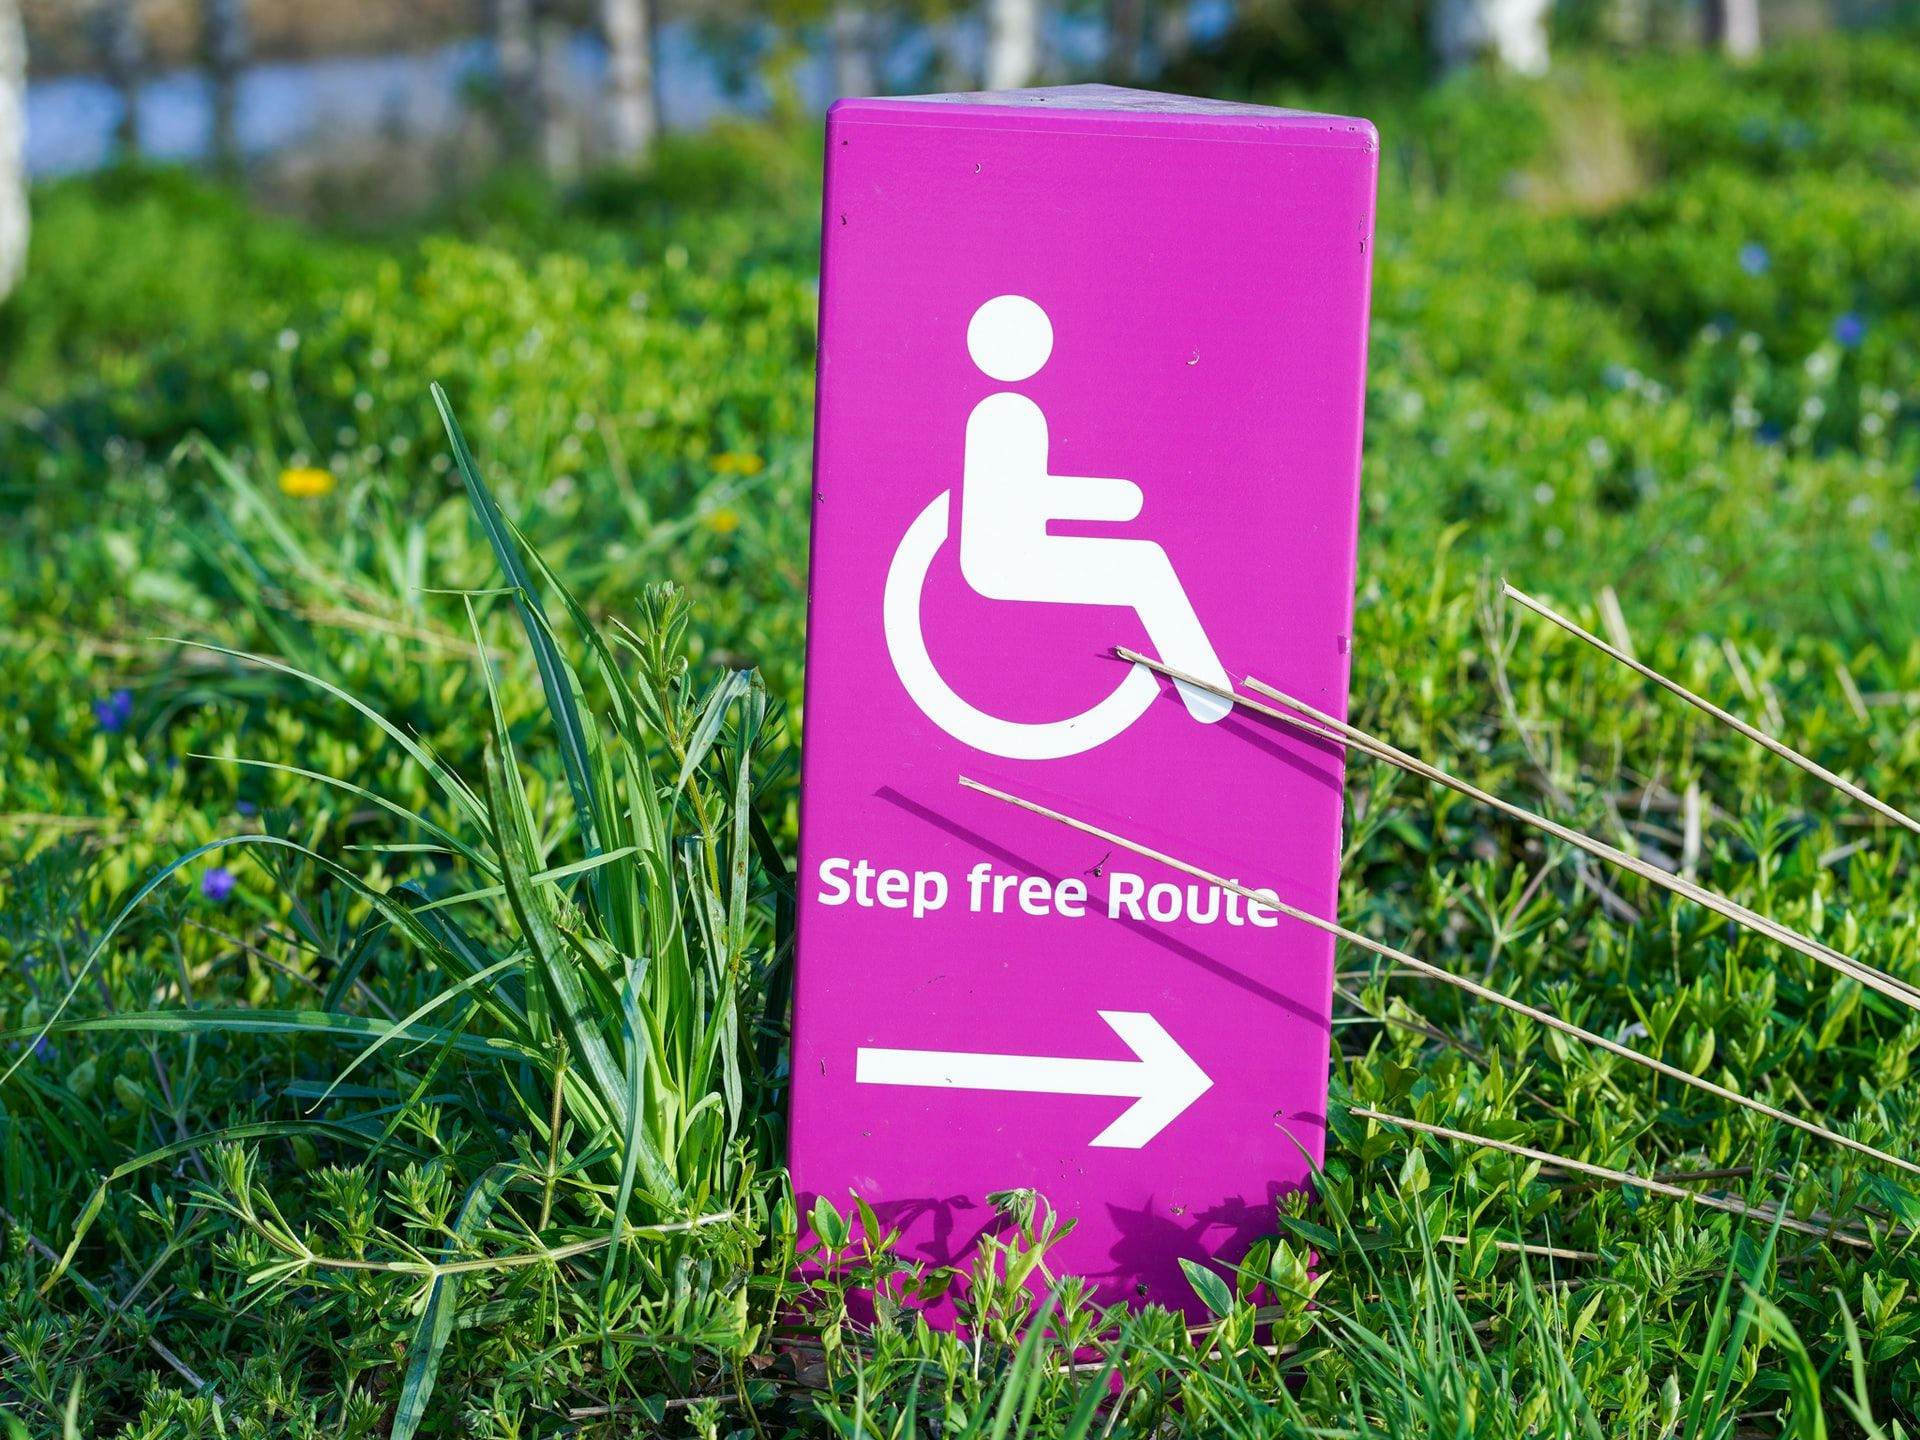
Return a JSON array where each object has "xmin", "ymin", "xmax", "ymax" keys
[{"xmin": 852, "ymin": 1010, "xmax": 1213, "ymax": 1150}]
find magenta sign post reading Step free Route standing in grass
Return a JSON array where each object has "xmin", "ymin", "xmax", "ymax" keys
[{"xmin": 791, "ymin": 86, "xmax": 1377, "ymax": 1309}]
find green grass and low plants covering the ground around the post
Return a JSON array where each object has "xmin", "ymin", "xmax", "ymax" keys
[{"xmin": 0, "ymin": 25, "xmax": 1920, "ymax": 1438}]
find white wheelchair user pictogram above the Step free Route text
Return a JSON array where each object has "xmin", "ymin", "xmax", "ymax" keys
[{"xmin": 881, "ymin": 296, "xmax": 1233, "ymax": 760}]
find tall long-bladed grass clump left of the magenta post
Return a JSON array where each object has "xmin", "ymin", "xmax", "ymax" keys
[{"xmin": 10, "ymin": 388, "xmax": 793, "ymax": 1440}]
